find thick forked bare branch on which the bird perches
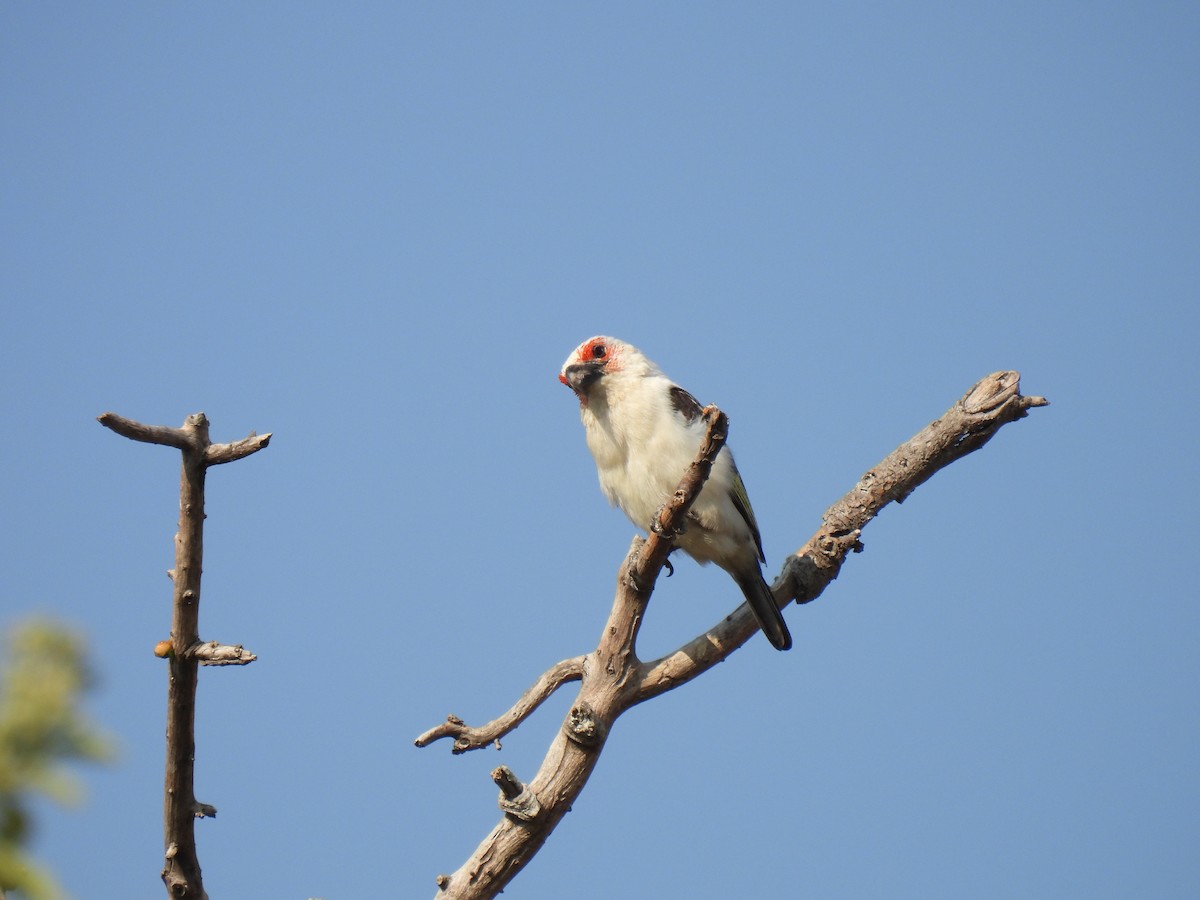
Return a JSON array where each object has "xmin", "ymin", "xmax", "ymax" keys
[{"xmin": 416, "ymin": 372, "xmax": 1046, "ymax": 900}]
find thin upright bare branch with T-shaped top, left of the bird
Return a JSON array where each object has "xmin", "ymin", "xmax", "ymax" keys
[{"xmin": 98, "ymin": 413, "xmax": 271, "ymax": 900}]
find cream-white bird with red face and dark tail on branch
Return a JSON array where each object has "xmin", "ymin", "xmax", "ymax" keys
[{"xmin": 558, "ymin": 335, "xmax": 792, "ymax": 650}]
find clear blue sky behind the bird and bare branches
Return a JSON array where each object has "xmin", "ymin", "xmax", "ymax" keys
[{"xmin": 0, "ymin": 2, "xmax": 1200, "ymax": 900}]
